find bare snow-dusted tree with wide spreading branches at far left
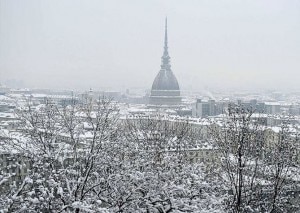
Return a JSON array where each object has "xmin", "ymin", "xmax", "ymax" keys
[{"xmin": 0, "ymin": 99, "xmax": 118, "ymax": 212}]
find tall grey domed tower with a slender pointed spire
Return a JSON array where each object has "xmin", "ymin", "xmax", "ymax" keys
[{"xmin": 149, "ymin": 18, "xmax": 181, "ymax": 107}]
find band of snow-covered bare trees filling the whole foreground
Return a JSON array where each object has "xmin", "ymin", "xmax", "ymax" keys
[{"xmin": 0, "ymin": 99, "xmax": 299, "ymax": 212}]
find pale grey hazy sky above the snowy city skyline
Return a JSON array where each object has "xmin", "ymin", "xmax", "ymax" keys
[{"xmin": 0, "ymin": 0, "xmax": 300, "ymax": 90}]
